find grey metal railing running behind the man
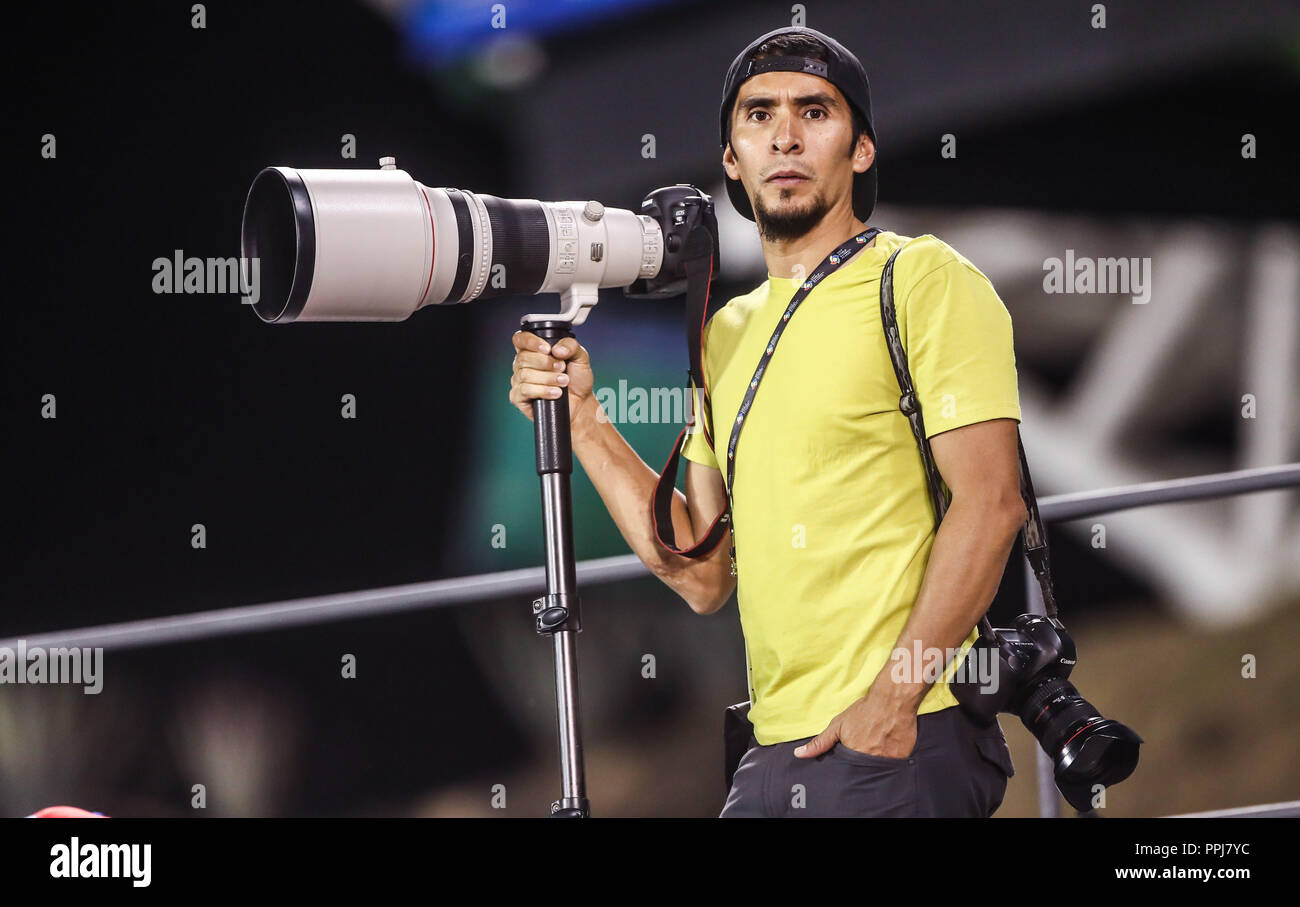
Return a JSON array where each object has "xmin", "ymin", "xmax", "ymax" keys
[{"xmin": 0, "ymin": 463, "xmax": 1300, "ymax": 819}]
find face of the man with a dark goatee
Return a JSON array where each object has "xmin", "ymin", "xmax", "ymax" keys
[{"xmin": 723, "ymin": 73, "xmax": 875, "ymax": 240}]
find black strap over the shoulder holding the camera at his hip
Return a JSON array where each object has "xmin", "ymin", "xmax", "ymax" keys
[{"xmin": 880, "ymin": 247, "xmax": 1057, "ymax": 618}]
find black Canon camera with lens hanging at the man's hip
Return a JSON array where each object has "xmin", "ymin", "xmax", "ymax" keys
[{"xmin": 949, "ymin": 615, "xmax": 1143, "ymax": 811}]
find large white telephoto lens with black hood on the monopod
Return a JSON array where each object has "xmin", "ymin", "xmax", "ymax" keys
[{"xmin": 241, "ymin": 166, "xmax": 663, "ymax": 322}]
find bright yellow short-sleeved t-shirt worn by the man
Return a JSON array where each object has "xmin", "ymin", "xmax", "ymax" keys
[{"xmin": 683, "ymin": 230, "xmax": 1021, "ymax": 746}]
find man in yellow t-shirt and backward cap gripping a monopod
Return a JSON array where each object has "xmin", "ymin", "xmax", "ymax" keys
[{"xmin": 511, "ymin": 27, "xmax": 1026, "ymax": 817}]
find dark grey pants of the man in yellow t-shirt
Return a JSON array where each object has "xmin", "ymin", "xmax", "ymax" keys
[{"xmin": 720, "ymin": 706, "xmax": 1015, "ymax": 819}]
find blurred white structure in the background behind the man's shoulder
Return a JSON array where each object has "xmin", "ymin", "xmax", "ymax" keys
[{"xmin": 714, "ymin": 185, "xmax": 1300, "ymax": 625}]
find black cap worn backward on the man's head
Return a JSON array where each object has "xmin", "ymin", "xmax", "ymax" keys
[{"xmin": 719, "ymin": 26, "xmax": 879, "ymax": 224}]
